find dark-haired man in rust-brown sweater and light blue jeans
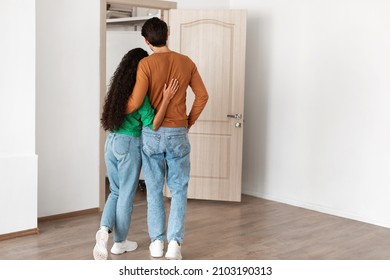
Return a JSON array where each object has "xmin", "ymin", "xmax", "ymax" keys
[{"xmin": 127, "ymin": 17, "xmax": 208, "ymax": 259}]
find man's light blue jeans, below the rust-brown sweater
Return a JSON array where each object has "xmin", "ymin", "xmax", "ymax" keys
[{"xmin": 142, "ymin": 127, "xmax": 191, "ymax": 244}]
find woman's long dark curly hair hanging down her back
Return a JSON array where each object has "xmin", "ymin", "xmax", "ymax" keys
[{"xmin": 100, "ymin": 48, "xmax": 148, "ymax": 131}]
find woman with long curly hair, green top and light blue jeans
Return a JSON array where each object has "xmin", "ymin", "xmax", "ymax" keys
[{"xmin": 93, "ymin": 48, "xmax": 179, "ymax": 260}]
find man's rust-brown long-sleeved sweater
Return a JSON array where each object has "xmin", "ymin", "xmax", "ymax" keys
[{"xmin": 126, "ymin": 51, "xmax": 208, "ymax": 127}]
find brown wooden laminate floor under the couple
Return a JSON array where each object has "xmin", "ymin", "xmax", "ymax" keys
[{"xmin": 0, "ymin": 192, "xmax": 390, "ymax": 260}]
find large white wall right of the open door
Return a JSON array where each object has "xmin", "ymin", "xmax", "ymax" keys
[{"xmin": 230, "ymin": 0, "xmax": 390, "ymax": 227}]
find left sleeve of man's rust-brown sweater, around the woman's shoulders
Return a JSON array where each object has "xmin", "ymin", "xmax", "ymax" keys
[{"xmin": 126, "ymin": 60, "xmax": 149, "ymax": 114}]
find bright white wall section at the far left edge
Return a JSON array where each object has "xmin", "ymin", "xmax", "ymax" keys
[{"xmin": 0, "ymin": 0, "xmax": 37, "ymax": 235}]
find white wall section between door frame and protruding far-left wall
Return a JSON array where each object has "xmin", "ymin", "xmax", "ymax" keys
[{"xmin": 36, "ymin": 0, "xmax": 100, "ymax": 217}]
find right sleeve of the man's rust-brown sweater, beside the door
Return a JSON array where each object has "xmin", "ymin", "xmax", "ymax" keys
[{"xmin": 188, "ymin": 65, "xmax": 209, "ymax": 127}]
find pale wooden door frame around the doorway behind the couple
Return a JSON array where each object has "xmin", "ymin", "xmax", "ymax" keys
[{"xmin": 99, "ymin": 0, "xmax": 177, "ymax": 211}]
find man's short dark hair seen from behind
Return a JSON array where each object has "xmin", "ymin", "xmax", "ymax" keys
[{"xmin": 141, "ymin": 17, "xmax": 168, "ymax": 47}]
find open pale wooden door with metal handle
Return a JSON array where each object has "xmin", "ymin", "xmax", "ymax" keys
[{"xmin": 168, "ymin": 10, "xmax": 246, "ymax": 201}]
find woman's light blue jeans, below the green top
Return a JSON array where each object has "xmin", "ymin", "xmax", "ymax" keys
[{"xmin": 100, "ymin": 133, "xmax": 141, "ymax": 242}]
